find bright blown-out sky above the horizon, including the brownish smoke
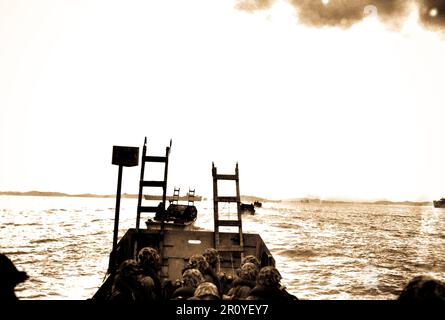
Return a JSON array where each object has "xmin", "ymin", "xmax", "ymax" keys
[{"xmin": 0, "ymin": 0, "xmax": 445, "ymax": 201}]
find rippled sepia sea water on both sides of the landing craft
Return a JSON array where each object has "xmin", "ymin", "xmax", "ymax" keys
[{"xmin": 0, "ymin": 196, "xmax": 445, "ymax": 300}]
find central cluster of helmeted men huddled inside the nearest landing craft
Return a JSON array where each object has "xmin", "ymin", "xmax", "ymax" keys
[{"xmin": 109, "ymin": 247, "xmax": 298, "ymax": 301}]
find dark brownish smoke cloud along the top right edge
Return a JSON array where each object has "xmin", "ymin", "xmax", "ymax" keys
[{"xmin": 237, "ymin": 0, "xmax": 445, "ymax": 30}]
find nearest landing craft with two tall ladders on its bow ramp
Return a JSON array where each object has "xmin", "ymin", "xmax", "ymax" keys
[{"xmin": 93, "ymin": 138, "xmax": 275, "ymax": 300}]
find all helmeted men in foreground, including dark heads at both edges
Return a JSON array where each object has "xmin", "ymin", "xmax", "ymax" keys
[{"xmin": 0, "ymin": 251, "xmax": 445, "ymax": 302}]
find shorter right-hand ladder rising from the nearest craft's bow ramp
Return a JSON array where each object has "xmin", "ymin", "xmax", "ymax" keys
[{"xmin": 212, "ymin": 162, "xmax": 244, "ymax": 253}]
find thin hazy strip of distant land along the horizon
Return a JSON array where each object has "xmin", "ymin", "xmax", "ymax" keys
[{"xmin": 0, "ymin": 191, "xmax": 433, "ymax": 206}]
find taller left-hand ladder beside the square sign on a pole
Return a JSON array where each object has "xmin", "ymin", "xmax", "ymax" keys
[{"xmin": 136, "ymin": 137, "xmax": 172, "ymax": 232}]
